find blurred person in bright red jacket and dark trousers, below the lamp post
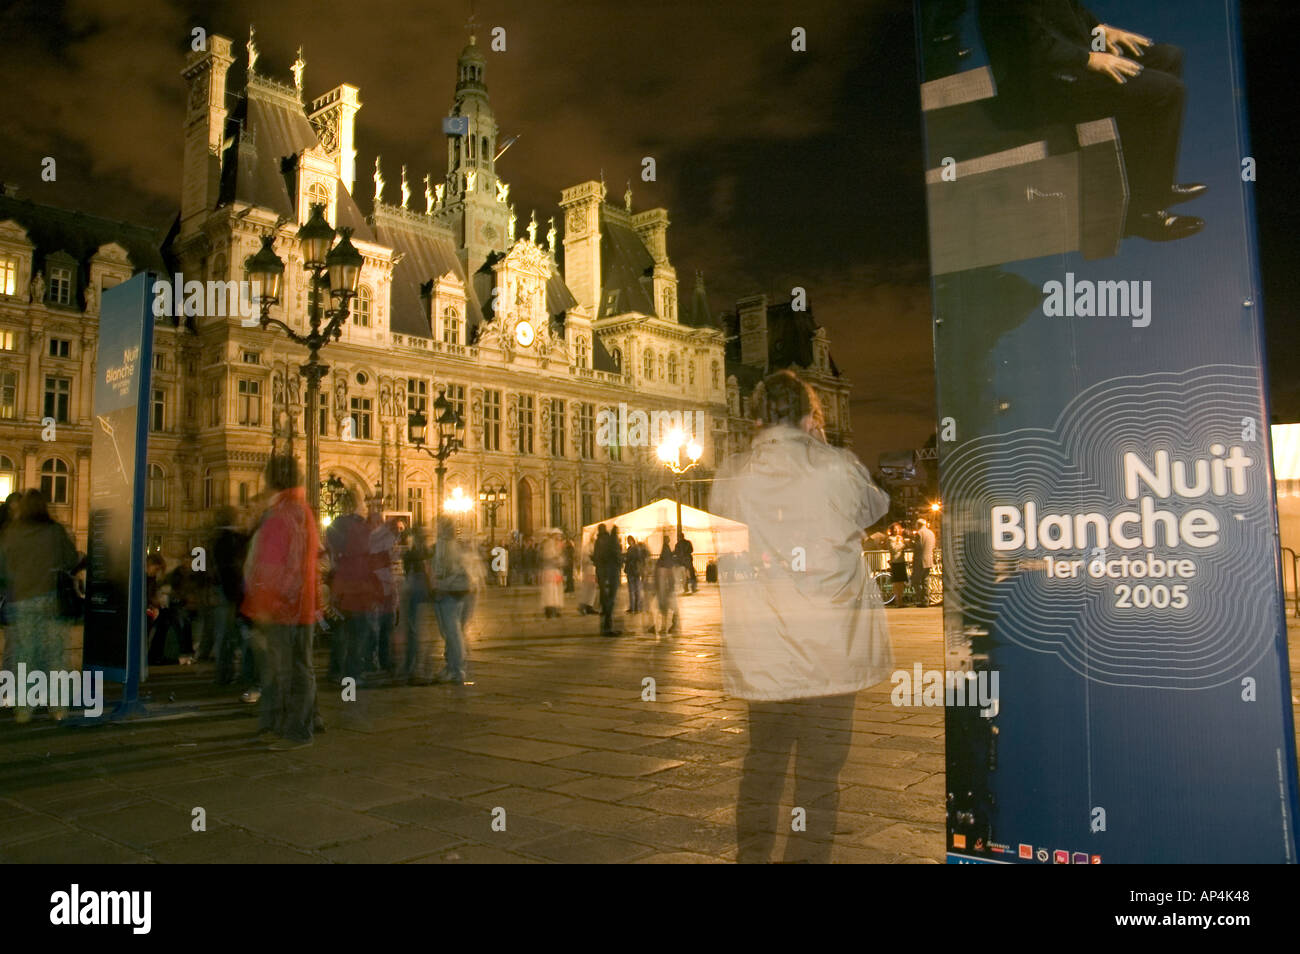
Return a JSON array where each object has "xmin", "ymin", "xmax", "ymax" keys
[{"xmin": 241, "ymin": 456, "xmax": 320, "ymax": 751}]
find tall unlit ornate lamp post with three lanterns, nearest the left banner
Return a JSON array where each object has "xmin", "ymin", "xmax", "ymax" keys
[{"xmin": 244, "ymin": 203, "xmax": 365, "ymax": 513}]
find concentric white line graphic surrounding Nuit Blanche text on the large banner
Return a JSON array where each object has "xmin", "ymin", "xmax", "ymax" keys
[{"xmin": 941, "ymin": 365, "xmax": 1278, "ymax": 689}]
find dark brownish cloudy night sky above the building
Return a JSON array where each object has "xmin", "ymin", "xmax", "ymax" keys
[{"xmin": 0, "ymin": 0, "xmax": 1300, "ymax": 465}]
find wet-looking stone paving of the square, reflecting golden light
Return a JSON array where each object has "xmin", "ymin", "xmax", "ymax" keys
[{"xmin": 0, "ymin": 590, "xmax": 1300, "ymax": 864}]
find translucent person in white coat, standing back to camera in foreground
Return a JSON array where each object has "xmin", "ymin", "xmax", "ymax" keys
[{"xmin": 710, "ymin": 370, "xmax": 893, "ymax": 862}]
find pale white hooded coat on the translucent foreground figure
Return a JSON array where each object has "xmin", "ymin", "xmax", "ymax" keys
[{"xmin": 710, "ymin": 425, "xmax": 893, "ymax": 702}]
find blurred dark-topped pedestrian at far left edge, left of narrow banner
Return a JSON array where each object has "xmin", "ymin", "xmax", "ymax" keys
[{"xmin": 0, "ymin": 489, "xmax": 81, "ymax": 723}]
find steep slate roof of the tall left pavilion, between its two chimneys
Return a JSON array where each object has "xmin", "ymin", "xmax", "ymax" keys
[{"xmin": 217, "ymin": 77, "xmax": 374, "ymax": 242}]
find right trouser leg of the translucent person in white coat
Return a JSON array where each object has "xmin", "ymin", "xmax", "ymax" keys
[{"xmin": 785, "ymin": 693, "xmax": 857, "ymax": 864}]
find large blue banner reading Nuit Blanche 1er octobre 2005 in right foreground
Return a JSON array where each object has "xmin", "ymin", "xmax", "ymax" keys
[{"xmin": 919, "ymin": 0, "xmax": 1297, "ymax": 864}]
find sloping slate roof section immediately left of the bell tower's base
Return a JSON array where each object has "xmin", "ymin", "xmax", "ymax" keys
[{"xmin": 374, "ymin": 205, "xmax": 484, "ymax": 341}]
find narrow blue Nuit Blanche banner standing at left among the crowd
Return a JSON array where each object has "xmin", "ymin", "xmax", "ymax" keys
[{"xmin": 85, "ymin": 273, "xmax": 153, "ymax": 703}]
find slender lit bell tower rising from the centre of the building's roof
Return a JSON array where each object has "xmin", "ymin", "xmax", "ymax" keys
[{"xmin": 434, "ymin": 35, "xmax": 510, "ymax": 276}]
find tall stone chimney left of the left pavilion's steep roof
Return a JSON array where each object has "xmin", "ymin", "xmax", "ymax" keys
[{"xmin": 181, "ymin": 34, "xmax": 234, "ymax": 238}]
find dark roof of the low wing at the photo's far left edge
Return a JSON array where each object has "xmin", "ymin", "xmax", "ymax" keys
[{"xmin": 0, "ymin": 194, "xmax": 173, "ymax": 296}]
